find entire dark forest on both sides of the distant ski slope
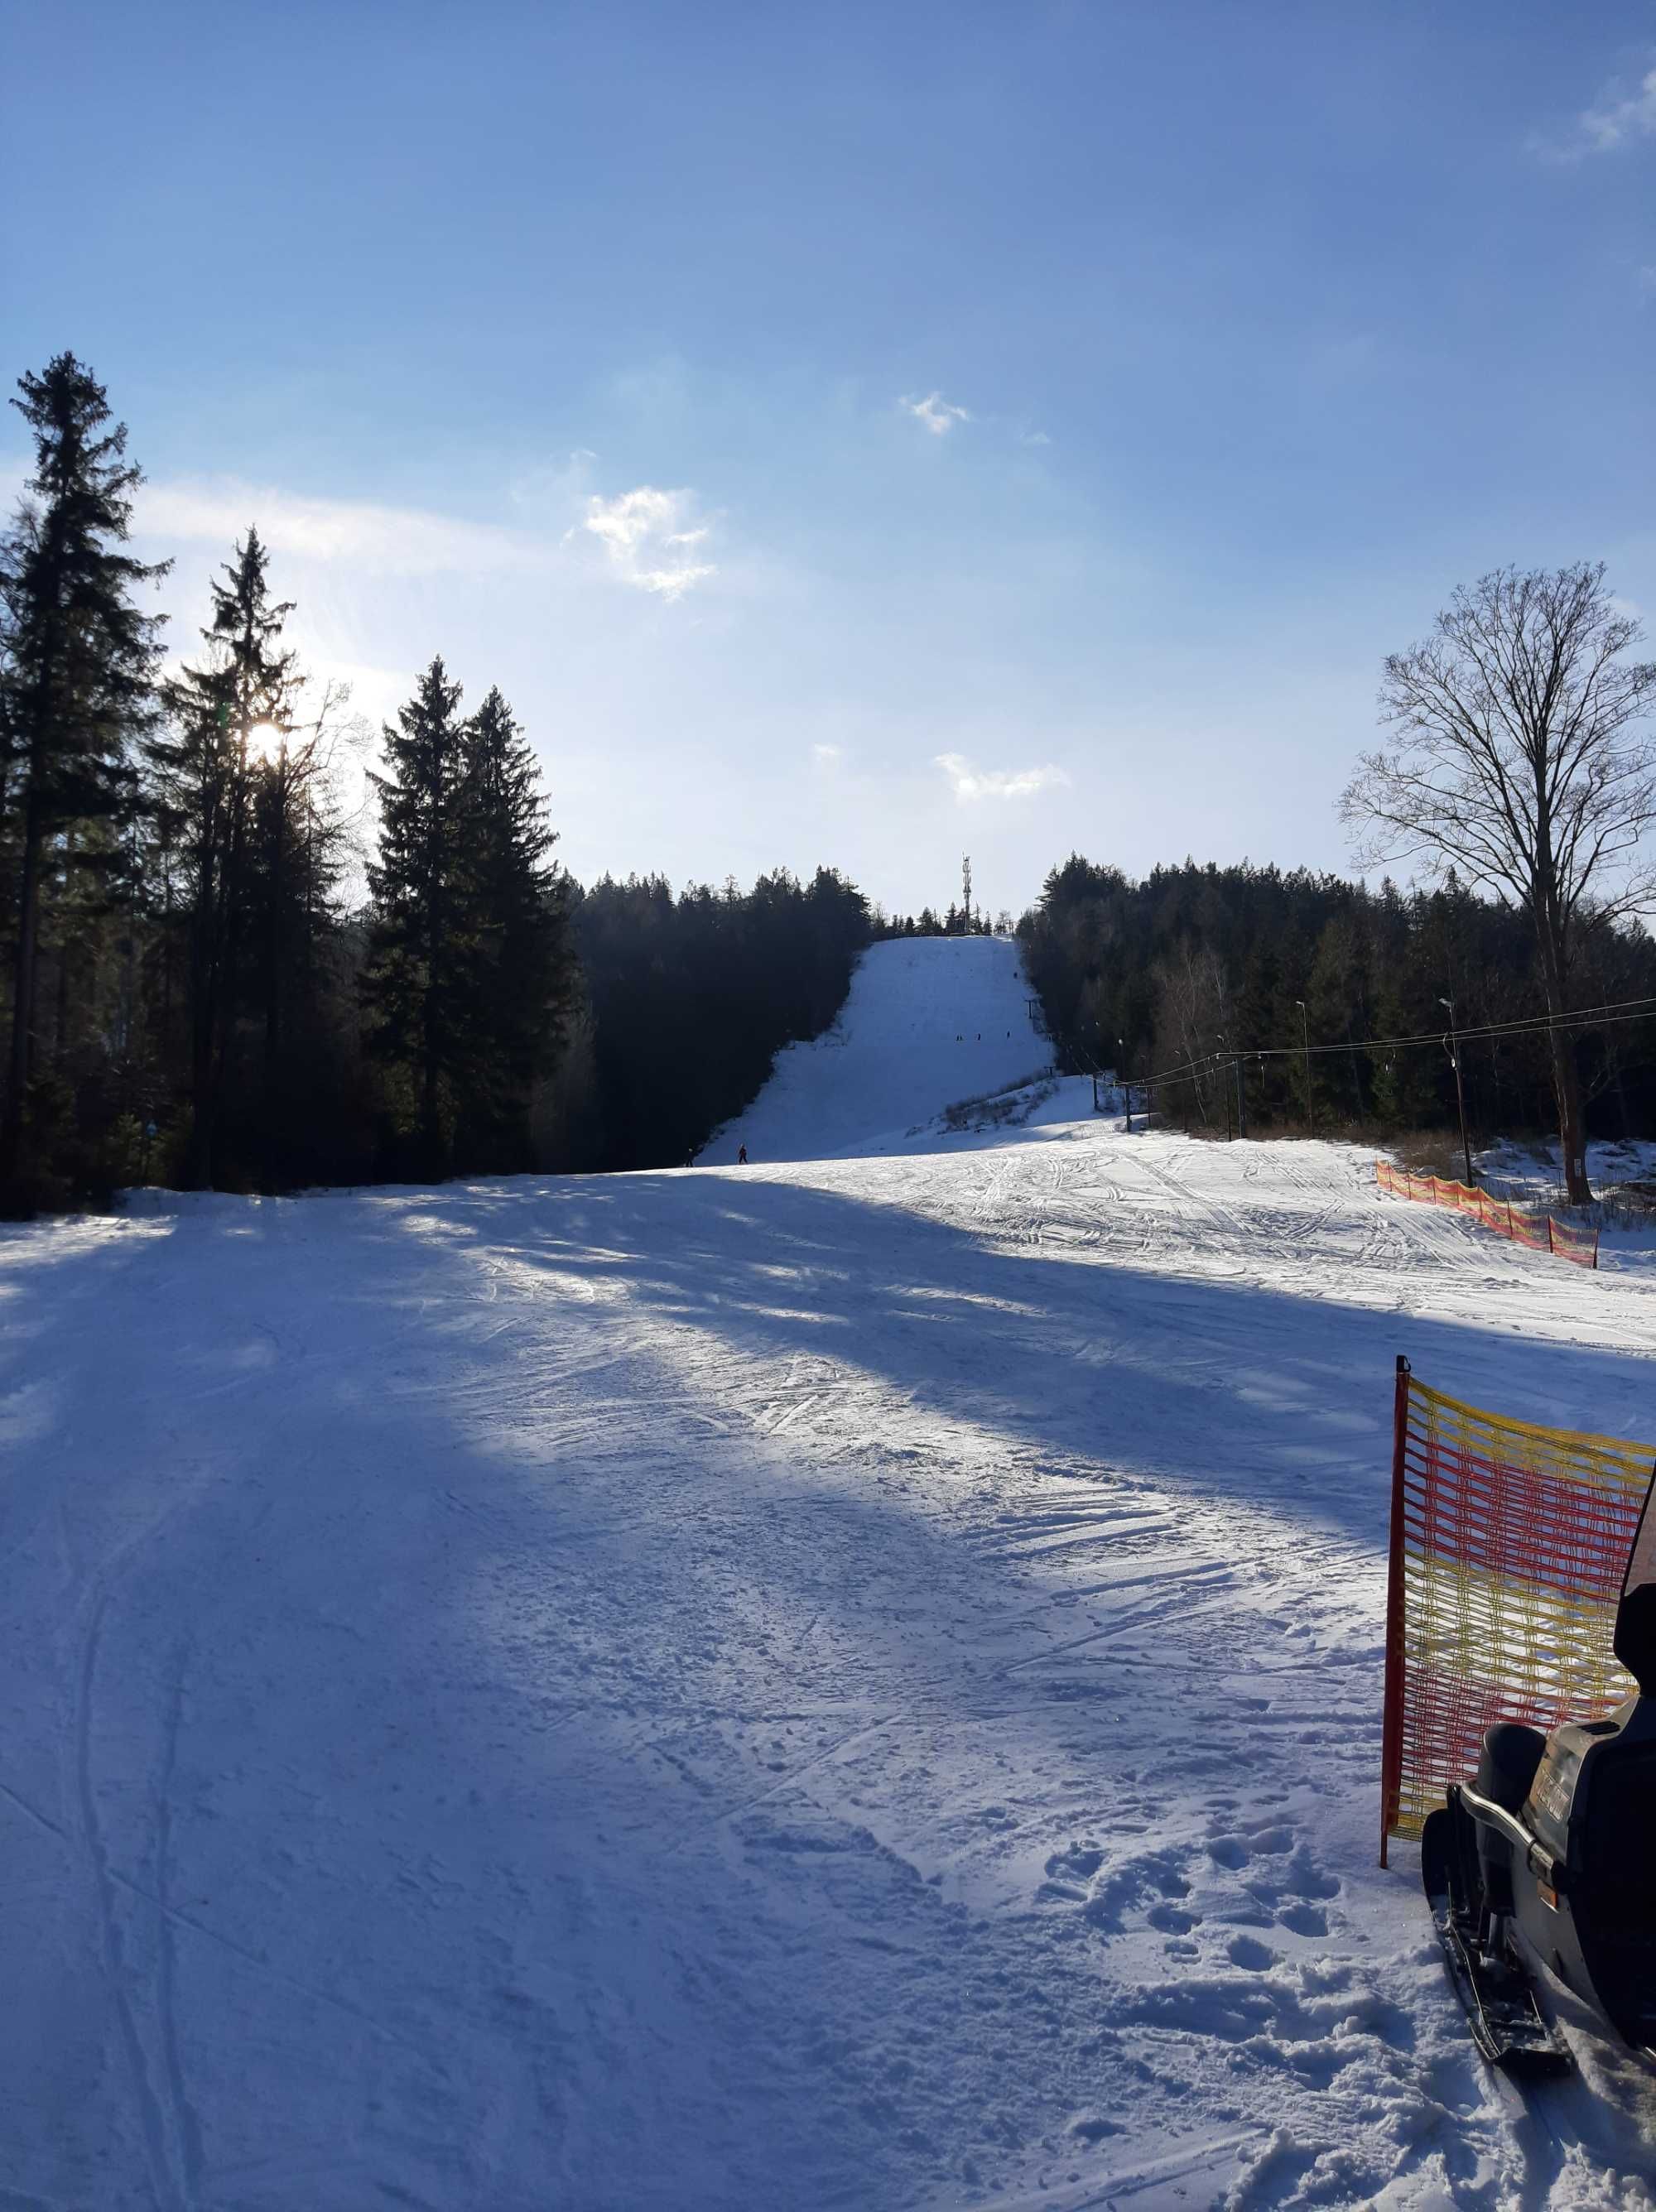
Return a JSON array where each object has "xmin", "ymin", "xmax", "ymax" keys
[{"xmin": 0, "ymin": 354, "xmax": 1656, "ymax": 1214}]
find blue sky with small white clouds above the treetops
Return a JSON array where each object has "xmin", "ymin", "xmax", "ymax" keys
[{"xmin": 0, "ymin": 0, "xmax": 1656, "ymax": 909}]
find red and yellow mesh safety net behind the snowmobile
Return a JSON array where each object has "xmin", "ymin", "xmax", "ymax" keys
[{"xmin": 1379, "ymin": 1358, "xmax": 1656, "ymax": 1867}]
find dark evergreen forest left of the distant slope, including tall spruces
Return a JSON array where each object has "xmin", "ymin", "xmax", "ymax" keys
[{"xmin": 0, "ymin": 354, "xmax": 875, "ymax": 1214}]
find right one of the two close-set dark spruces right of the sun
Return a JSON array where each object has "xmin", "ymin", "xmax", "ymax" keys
[{"xmin": 462, "ymin": 688, "xmax": 577, "ymax": 1168}]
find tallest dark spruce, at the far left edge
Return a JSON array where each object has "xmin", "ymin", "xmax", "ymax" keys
[{"xmin": 0, "ymin": 354, "xmax": 168, "ymax": 1210}]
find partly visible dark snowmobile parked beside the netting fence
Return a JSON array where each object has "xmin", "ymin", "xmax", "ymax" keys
[{"xmin": 1419, "ymin": 1478, "xmax": 1656, "ymax": 2073}]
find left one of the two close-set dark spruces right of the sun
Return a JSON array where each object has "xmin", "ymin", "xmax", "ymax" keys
[{"xmin": 363, "ymin": 659, "xmax": 478, "ymax": 1175}]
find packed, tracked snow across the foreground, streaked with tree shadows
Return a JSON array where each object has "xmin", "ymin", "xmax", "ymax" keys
[{"xmin": 0, "ymin": 1114, "xmax": 1656, "ymax": 2212}]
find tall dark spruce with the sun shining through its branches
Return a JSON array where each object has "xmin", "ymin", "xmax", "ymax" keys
[{"xmin": 148, "ymin": 529, "xmax": 303, "ymax": 1188}]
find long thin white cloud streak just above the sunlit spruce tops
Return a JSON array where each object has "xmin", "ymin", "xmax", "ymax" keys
[{"xmin": 132, "ymin": 478, "xmax": 530, "ymax": 575}]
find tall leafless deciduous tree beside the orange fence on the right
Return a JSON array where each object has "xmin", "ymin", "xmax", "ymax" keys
[{"xmin": 1340, "ymin": 562, "xmax": 1656, "ymax": 1201}]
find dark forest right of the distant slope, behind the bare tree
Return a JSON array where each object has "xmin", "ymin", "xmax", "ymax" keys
[{"xmin": 1019, "ymin": 854, "xmax": 1656, "ymax": 1137}]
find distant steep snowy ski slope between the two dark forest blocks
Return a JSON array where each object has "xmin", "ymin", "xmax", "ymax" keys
[{"xmin": 699, "ymin": 938, "xmax": 1052, "ymax": 1166}]
